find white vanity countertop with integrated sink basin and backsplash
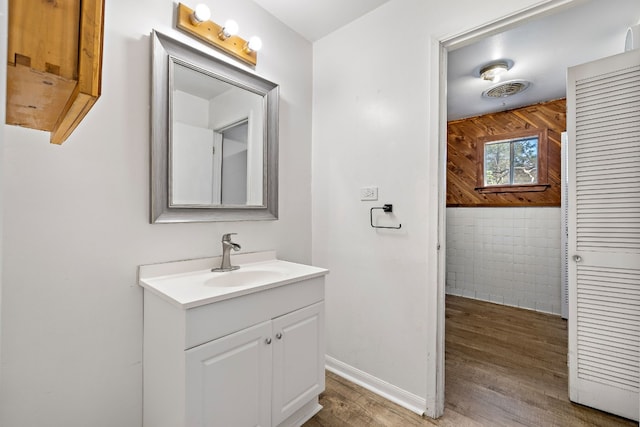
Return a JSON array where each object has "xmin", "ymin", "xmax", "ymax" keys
[{"xmin": 138, "ymin": 251, "xmax": 329, "ymax": 309}]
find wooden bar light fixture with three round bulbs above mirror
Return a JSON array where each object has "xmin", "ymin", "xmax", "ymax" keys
[{"xmin": 176, "ymin": 3, "xmax": 262, "ymax": 66}]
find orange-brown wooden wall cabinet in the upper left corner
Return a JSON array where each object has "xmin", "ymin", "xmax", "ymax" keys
[{"xmin": 6, "ymin": 0, "xmax": 104, "ymax": 144}]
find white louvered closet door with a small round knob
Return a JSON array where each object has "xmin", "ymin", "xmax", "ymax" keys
[{"xmin": 567, "ymin": 50, "xmax": 640, "ymax": 420}]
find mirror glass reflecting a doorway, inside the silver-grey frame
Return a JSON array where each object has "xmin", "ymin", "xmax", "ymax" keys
[{"xmin": 169, "ymin": 63, "xmax": 264, "ymax": 206}]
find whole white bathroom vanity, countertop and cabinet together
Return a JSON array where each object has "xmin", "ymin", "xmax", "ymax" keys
[{"xmin": 139, "ymin": 252, "xmax": 328, "ymax": 427}]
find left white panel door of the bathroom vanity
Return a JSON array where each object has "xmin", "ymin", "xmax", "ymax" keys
[{"xmin": 186, "ymin": 321, "xmax": 272, "ymax": 427}]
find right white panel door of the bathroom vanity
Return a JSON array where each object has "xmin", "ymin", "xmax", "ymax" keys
[{"xmin": 272, "ymin": 303, "xmax": 325, "ymax": 426}]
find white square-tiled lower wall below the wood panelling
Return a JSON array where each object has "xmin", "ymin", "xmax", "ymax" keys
[{"xmin": 447, "ymin": 207, "xmax": 561, "ymax": 314}]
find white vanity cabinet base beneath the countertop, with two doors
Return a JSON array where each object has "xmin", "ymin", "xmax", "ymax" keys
[{"xmin": 143, "ymin": 277, "xmax": 325, "ymax": 427}]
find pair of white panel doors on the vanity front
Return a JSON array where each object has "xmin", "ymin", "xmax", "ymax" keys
[{"xmin": 186, "ymin": 302, "xmax": 324, "ymax": 426}]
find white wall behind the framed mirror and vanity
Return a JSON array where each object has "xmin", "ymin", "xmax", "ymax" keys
[{"xmin": 0, "ymin": 0, "xmax": 312, "ymax": 427}]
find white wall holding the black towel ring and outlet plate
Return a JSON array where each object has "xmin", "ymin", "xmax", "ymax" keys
[{"xmin": 313, "ymin": 0, "xmax": 564, "ymax": 418}]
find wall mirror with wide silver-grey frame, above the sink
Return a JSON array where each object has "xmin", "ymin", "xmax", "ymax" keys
[{"xmin": 151, "ymin": 31, "xmax": 278, "ymax": 223}]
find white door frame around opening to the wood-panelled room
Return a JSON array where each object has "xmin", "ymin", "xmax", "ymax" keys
[{"xmin": 425, "ymin": 0, "xmax": 583, "ymax": 418}]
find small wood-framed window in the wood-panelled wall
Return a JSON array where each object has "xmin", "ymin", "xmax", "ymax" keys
[{"xmin": 476, "ymin": 129, "xmax": 548, "ymax": 193}]
